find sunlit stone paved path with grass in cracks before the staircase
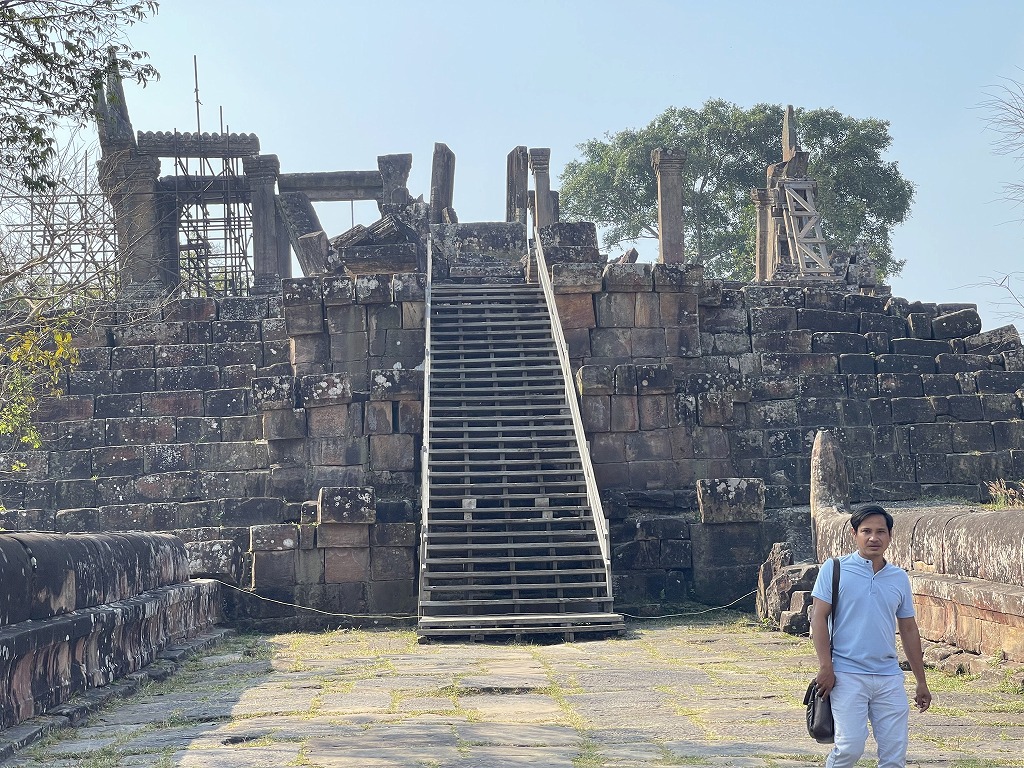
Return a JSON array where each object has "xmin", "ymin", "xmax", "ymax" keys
[{"xmin": 8, "ymin": 611, "xmax": 1024, "ymax": 768}]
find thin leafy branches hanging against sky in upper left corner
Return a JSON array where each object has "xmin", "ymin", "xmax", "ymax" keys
[{"xmin": 0, "ymin": 0, "xmax": 158, "ymax": 188}]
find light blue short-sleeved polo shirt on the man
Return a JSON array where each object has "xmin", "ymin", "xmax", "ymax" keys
[{"xmin": 811, "ymin": 552, "xmax": 913, "ymax": 675}]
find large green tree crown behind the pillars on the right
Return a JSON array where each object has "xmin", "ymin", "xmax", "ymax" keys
[{"xmin": 559, "ymin": 99, "xmax": 913, "ymax": 280}]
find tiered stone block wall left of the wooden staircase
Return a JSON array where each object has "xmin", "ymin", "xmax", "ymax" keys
[{"xmin": 0, "ymin": 273, "xmax": 425, "ymax": 615}]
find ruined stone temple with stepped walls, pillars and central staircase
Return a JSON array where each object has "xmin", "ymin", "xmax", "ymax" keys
[{"xmin": 0, "ymin": 72, "xmax": 1024, "ymax": 729}]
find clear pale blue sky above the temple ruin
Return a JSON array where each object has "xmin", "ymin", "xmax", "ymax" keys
[{"xmin": 119, "ymin": 0, "xmax": 1024, "ymax": 330}]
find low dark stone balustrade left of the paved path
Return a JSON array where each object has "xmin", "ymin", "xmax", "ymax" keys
[{"xmin": 0, "ymin": 532, "xmax": 220, "ymax": 728}]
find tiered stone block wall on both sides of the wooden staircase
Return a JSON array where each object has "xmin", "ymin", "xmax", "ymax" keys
[{"xmin": 0, "ymin": 259, "xmax": 1024, "ymax": 615}]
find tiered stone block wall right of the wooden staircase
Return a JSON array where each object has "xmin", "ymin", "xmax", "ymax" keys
[{"xmin": 552, "ymin": 274, "xmax": 1024, "ymax": 600}]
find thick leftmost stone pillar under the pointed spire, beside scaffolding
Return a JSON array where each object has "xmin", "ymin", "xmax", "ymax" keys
[{"xmin": 97, "ymin": 150, "xmax": 164, "ymax": 294}]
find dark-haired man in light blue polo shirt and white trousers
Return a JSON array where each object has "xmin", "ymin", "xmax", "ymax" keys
[{"xmin": 811, "ymin": 504, "xmax": 932, "ymax": 768}]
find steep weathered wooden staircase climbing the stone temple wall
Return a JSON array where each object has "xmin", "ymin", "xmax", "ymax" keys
[{"xmin": 419, "ymin": 284, "xmax": 623, "ymax": 640}]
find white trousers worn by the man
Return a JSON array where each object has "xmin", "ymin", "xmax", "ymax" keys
[{"xmin": 825, "ymin": 672, "xmax": 910, "ymax": 768}]
